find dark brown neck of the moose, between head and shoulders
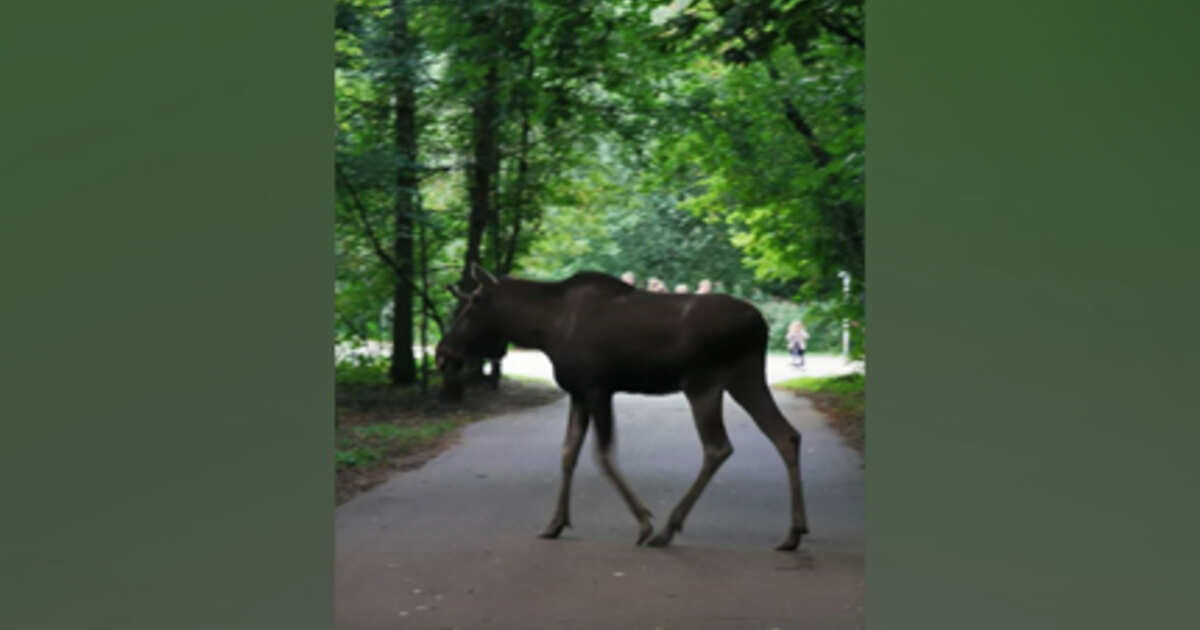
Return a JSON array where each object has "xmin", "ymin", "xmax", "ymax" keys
[{"xmin": 493, "ymin": 278, "xmax": 563, "ymax": 352}]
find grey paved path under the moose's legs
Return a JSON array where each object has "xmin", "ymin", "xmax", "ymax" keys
[{"xmin": 335, "ymin": 350, "xmax": 864, "ymax": 630}]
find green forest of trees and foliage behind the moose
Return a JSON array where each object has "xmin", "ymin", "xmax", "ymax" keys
[{"xmin": 334, "ymin": 0, "xmax": 866, "ymax": 385}]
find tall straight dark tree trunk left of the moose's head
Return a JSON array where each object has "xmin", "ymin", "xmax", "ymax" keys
[{"xmin": 390, "ymin": 0, "xmax": 418, "ymax": 385}]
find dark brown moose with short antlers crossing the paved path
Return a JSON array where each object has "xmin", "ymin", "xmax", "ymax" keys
[{"xmin": 434, "ymin": 265, "xmax": 808, "ymax": 551}]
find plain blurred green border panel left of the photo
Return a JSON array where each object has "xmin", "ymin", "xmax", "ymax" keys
[{"xmin": 0, "ymin": 0, "xmax": 334, "ymax": 630}]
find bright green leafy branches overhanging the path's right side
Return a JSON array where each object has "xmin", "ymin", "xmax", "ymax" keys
[{"xmin": 655, "ymin": 1, "xmax": 864, "ymax": 320}]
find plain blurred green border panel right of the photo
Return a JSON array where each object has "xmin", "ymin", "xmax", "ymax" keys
[{"xmin": 866, "ymin": 1, "xmax": 1200, "ymax": 630}]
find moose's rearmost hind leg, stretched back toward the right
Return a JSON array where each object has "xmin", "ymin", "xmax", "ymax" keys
[{"xmin": 730, "ymin": 372, "xmax": 809, "ymax": 551}]
